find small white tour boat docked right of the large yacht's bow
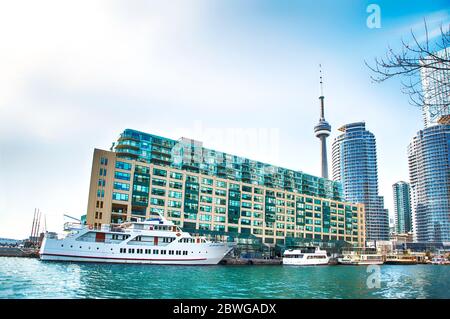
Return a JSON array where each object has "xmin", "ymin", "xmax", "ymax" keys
[{"xmin": 283, "ymin": 247, "xmax": 330, "ymax": 266}]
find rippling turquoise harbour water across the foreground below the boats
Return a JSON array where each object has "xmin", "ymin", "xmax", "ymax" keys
[{"xmin": 0, "ymin": 257, "xmax": 450, "ymax": 298}]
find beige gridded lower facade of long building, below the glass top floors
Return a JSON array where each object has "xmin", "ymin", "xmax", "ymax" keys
[{"xmin": 86, "ymin": 149, "xmax": 365, "ymax": 247}]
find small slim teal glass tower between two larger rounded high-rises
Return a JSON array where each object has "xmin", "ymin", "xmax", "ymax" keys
[{"xmin": 392, "ymin": 181, "xmax": 412, "ymax": 234}]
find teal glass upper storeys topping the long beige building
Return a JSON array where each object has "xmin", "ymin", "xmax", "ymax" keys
[{"xmin": 113, "ymin": 129, "xmax": 343, "ymax": 201}]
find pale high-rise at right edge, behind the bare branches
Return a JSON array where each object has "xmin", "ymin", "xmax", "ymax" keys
[{"xmin": 421, "ymin": 48, "xmax": 450, "ymax": 127}]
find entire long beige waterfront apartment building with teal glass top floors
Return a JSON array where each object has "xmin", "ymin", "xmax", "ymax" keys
[{"xmin": 87, "ymin": 129, "xmax": 365, "ymax": 246}]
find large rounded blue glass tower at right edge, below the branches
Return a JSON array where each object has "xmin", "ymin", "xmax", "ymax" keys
[{"xmin": 408, "ymin": 121, "xmax": 450, "ymax": 242}]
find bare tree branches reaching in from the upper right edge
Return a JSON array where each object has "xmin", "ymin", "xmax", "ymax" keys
[{"xmin": 365, "ymin": 20, "xmax": 450, "ymax": 121}]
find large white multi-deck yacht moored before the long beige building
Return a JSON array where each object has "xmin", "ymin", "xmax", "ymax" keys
[{"xmin": 39, "ymin": 215, "xmax": 233, "ymax": 265}]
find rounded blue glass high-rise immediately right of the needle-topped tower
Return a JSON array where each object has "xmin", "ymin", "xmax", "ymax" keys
[{"xmin": 332, "ymin": 122, "xmax": 389, "ymax": 241}]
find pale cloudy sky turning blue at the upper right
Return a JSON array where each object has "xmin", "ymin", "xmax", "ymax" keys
[{"xmin": 0, "ymin": 0, "xmax": 450, "ymax": 239}]
